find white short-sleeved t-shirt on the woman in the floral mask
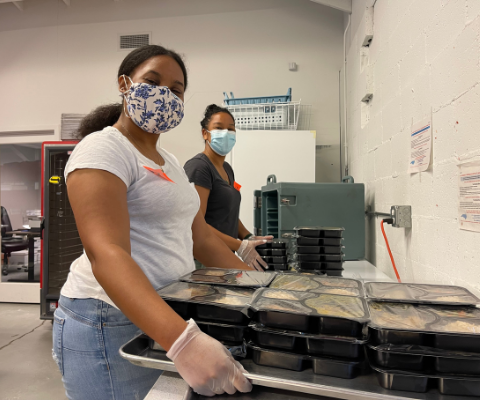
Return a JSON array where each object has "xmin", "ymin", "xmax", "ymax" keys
[{"xmin": 61, "ymin": 127, "xmax": 200, "ymax": 306}]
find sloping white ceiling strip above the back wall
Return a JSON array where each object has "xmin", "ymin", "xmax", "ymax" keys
[{"xmin": 0, "ymin": 0, "xmax": 352, "ymax": 31}]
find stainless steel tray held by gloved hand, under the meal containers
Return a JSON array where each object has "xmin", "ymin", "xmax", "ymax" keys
[{"xmin": 120, "ymin": 335, "xmax": 468, "ymax": 400}]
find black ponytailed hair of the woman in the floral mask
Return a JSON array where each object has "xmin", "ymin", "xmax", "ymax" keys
[{"xmin": 76, "ymin": 44, "xmax": 188, "ymax": 139}]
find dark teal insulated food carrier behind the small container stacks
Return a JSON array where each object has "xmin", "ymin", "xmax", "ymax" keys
[{"xmin": 254, "ymin": 175, "xmax": 365, "ymax": 260}]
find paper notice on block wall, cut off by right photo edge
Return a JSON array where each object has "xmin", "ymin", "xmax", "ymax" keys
[{"xmin": 458, "ymin": 161, "xmax": 480, "ymax": 232}]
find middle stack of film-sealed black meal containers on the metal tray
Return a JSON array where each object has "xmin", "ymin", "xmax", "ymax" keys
[{"xmin": 247, "ymin": 274, "xmax": 368, "ymax": 379}]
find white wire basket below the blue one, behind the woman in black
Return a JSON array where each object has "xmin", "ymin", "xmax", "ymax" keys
[{"xmin": 227, "ymin": 101, "xmax": 311, "ymax": 131}]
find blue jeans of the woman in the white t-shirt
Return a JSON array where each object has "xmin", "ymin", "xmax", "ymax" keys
[{"xmin": 53, "ymin": 296, "xmax": 162, "ymax": 400}]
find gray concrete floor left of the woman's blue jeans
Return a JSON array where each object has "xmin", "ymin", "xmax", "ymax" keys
[{"xmin": 0, "ymin": 303, "xmax": 66, "ymax": 400}]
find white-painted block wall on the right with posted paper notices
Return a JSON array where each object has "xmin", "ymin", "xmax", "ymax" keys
[{"xmin": 347, "ymin": 0, "xmax": 480, "ymax": 292}]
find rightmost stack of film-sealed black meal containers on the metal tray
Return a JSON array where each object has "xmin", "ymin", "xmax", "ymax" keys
[{"xmin": 365, "ymin": 282, "xmax": 480, "ymax": 399}]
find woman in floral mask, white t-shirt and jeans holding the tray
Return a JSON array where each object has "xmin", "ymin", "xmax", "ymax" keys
[{"xmin": 53, "ymin": 46, "xmax": 251, "ymax": 400}]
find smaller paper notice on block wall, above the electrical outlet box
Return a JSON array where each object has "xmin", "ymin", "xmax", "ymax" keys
[{"xmin": 409, "ymin": 118, "xmax": 432, "ymax": 174}]
